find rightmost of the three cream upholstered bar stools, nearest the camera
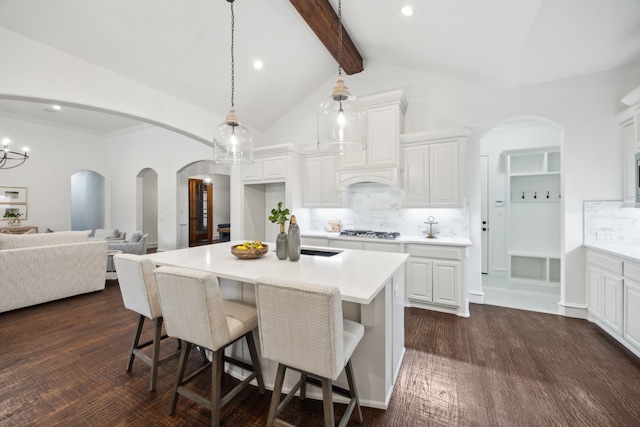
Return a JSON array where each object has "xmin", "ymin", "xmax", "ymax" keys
[{"xmin": 256, "ymin": 277, "xmax": 364, "ymax": 427}]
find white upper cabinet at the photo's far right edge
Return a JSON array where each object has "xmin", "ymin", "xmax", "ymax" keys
[{"xmin": 617, "ymin": 87, "xmax": 640, "ymax": 205}]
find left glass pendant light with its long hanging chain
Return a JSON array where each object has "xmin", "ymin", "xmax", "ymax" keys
[{"xmin": 213, "ymin": 0, "xmax": 253, "ymax": 166}]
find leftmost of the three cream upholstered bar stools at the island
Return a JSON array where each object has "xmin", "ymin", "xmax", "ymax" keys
[{"xmin": 113, "ymin": 254, "xmax": 180, "ymax": 391}]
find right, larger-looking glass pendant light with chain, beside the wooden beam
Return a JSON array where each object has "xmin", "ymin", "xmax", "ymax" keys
[{"xmin": 318, "ymin": 0, "xmax": 367, "ymax": 153}]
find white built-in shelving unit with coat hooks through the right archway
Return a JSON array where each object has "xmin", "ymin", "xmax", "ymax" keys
[{"xmin": 506, "ymin": 147, "xmax": 562, "ymax": 286}]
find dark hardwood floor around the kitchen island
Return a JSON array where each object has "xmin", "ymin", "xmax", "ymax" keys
[{"xmin": 0, "ymin": 282, "xmax": 640, "ymax": 426}]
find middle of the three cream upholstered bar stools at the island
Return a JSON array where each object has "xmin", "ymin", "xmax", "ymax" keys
[{"xmin": 155, "ymin": 267, "xmax": 264, "ymax": 426}]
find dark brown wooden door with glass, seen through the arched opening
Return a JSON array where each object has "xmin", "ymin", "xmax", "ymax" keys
[{"xmin": 189, "ymin": 178, "xmax": 213, "ymax": 246}]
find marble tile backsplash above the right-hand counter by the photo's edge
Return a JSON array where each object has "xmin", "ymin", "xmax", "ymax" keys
[{"xmin": 584, "ymin": 201, "xmax": 640, "ymax": 246}]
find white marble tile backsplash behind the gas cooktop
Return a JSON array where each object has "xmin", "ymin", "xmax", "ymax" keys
[{"xmin": 306, "ymin": 183, "xmax": 469, "ymax": 238}]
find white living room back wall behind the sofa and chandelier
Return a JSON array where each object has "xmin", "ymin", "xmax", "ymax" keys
[{"xmin": 0, "ymin": 115, "xmax": 109, "ymax": 232}]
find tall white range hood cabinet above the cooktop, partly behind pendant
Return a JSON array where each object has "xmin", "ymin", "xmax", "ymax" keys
[{"xmin": 338, "ymin": 91, "xmax": 407, "ymax": 187}]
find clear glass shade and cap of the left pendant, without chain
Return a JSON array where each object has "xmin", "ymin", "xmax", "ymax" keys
[{"xmin": 214, "ymin": 107, "xmax": 253, "ymax": 166}]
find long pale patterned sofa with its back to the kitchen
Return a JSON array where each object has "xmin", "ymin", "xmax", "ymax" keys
[{"xmin": 0, "ymin": 231, "xmax": 107, "ymax": 313}]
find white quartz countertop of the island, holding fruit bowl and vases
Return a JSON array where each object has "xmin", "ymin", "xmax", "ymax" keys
[{"xmin": 143, "ymin": 241, "xmax": 409, "ymax": 304}]
